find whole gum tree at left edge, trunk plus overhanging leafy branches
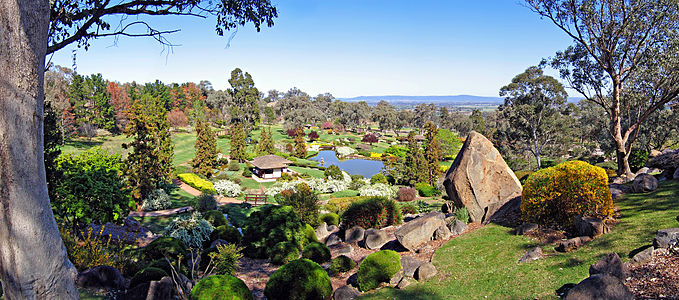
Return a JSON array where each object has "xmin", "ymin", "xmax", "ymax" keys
[{"xmin": 0, "ymin": 0, "xmax": 278, "ymax": 299}]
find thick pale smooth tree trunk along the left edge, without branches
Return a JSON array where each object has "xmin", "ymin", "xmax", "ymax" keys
[{"xmin": 0, "ymin": 0, "xmax": 78, "ymax": 299}]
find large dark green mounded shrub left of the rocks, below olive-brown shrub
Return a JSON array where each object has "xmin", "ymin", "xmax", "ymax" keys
[{"xmin": 242, "ymin": 205, "xmax": 305, "ymax": 258}]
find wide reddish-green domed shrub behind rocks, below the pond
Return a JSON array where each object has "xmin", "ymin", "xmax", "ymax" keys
[{"xmin": 341, "ymin": 197, "xmax": 401, "ymax": 230}]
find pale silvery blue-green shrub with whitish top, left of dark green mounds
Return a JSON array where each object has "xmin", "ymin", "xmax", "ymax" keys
[{"xmin": 164, "ymin": 212, "xmax": 214, "ymax": 248}]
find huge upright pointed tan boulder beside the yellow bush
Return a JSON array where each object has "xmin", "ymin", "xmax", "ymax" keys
[{"xmin": 443, "ymin": 131, "xmax": 522, "ymax": 223}]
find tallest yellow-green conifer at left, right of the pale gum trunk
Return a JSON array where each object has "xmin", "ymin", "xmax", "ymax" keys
[{"xmin": 123, "ymin": 93, "xmax": 174, "ymax": 207}]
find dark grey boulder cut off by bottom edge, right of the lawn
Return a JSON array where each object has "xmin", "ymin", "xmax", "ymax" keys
[{"xmin": 564, "ymin": 274, "xmax": 634, "ymax": 300}]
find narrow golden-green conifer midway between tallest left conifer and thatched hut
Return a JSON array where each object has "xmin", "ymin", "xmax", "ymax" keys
[{"xmin": 192, "ymin": 119, "xmax": 217, "ymax": 178}]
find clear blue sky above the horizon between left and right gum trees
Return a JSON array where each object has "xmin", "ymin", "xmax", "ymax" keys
[{"xmin": 48, "ymin": 0, "xmax": 571, "ymax": 97}]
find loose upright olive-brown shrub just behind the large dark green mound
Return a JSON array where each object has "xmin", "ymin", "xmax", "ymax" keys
[{"xmin": 279, "ymin": 183, "xmax": 318, "ymax": 227}]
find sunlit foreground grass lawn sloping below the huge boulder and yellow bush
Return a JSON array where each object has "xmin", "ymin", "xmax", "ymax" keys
[{"xmin": 361, "ymin": 182, "xmax": 679, "ymax": 299}]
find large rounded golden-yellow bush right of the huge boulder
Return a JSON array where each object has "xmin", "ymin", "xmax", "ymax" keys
[{"xmin": 521, "ymin": 161, "xmax": 613, "ymax": 228}]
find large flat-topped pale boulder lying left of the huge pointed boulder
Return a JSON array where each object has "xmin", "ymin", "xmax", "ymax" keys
[{"xmin": 394, "ymin": 212, "xmax": 446, "ymax": 251}]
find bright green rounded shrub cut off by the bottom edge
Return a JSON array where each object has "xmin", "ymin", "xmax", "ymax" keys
[{"xmin": 191, "ymin": 275, "xmax": 253, "ymax": 300}]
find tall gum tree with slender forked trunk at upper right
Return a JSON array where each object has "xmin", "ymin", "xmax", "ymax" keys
[{"xmin": 526, "ymin": 0, "xmax": 679, "ymax": 178}]
